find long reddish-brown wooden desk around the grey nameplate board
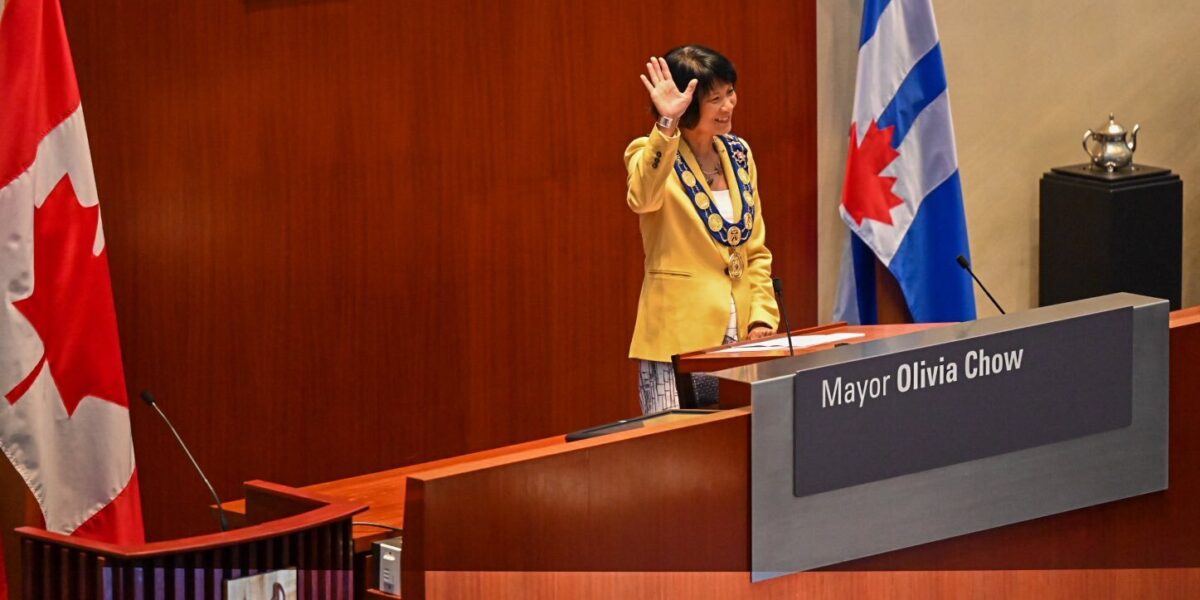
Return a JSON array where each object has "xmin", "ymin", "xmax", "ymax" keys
[{"xmin": 223, "ymin": 307, "xmax": 1200, "ymax": 600}]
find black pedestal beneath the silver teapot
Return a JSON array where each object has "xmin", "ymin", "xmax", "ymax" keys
[{"xmin": 1038, "ymin": 164, "xmax": 1183, "ymax": 310}]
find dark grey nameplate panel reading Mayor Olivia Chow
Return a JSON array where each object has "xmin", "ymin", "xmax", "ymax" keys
[{"xmin": 793, "ymin": 308, "xmax": 1133, "ymax": 497}]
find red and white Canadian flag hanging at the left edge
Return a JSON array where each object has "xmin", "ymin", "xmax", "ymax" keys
[{"xmin": 0, "ymin": 0, "xmax": 143, "ymax": 585}]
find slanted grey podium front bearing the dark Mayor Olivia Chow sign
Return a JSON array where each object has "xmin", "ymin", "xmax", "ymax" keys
[{"xmin": 721, "ymin": 294, "xmax": 1171, "ymax": 578}]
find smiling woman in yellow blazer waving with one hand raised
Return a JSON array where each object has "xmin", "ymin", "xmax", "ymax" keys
[{"xmin": 625, "ymin": 46, "xmax": 779, "ymax": 414}]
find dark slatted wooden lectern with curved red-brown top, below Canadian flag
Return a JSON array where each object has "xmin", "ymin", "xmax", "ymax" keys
[{"xmin": 12, "ymin": 481, "xmax": 366, "ymax": 600}]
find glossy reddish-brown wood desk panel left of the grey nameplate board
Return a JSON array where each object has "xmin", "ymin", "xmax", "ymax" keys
[{"xmin": 401, "ymin": 409, "xmax": 750, "ymax": 599}]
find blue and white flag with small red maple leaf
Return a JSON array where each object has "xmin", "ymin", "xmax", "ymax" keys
[{"xmin": 834, "ymin": 0, "xmax": 976, "ymax": 324}]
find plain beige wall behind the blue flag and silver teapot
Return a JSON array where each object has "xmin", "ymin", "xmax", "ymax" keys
[{"xmin": 817, "ymin": 0, "xmax": 1200, "ymax": 323}]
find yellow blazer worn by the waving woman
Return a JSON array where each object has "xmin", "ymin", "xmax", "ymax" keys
[{"xmin": 625, "ymin": 127, "xmax": 779, "ymax": 362}]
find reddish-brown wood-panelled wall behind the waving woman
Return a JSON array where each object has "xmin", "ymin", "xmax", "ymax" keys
[{"xmin": 62, "ymin": 0, "xmax": 816, "ymax": 539}]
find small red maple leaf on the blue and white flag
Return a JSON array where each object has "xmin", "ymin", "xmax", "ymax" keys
[{"xmin": 841, "ymin": 121, "xmax": 904, "ymax": 224}]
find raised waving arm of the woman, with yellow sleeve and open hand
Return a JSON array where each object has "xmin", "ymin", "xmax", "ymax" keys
[{"xmin": 625, "ymin": 58, "xmax": 696, "ymax": 214}]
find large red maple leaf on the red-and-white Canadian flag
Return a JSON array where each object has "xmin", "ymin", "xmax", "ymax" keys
[{"xmin": 5, "ymin": 175, "xmax": 128, "ymax": 415}]
